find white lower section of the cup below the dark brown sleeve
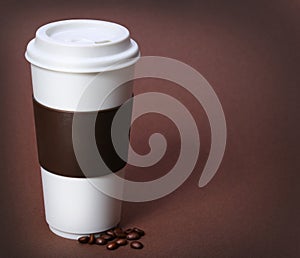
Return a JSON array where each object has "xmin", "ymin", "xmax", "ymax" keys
[{"xmin": 41, "ymin": 167, "xmax": 122, "ymax": 239}]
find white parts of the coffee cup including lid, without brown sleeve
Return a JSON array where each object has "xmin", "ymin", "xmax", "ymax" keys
[{"xmin": 25, "ymin": 20, "xmax": 139, "ymax": 239}]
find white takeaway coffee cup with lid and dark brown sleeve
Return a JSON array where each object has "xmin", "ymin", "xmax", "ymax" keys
[{"xmin": 25, "ymin": 20, "xmax": 139, "ymax": 239}]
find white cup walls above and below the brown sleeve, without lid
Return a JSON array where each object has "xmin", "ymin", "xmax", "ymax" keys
[{"xmin": 31, "ymin": 65, "xmax": 133, "ymax": 239}]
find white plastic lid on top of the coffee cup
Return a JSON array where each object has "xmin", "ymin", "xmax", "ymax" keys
[{"xmin": 25, "ymin": 20, "xmax": 139, "ymax": 73}]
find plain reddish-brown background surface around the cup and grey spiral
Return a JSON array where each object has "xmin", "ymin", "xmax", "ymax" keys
[{"xmin": 0, "ymin": 0, "xmax": 300, "ymax": 257}]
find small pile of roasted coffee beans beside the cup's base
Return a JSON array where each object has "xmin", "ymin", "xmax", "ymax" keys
[{"xmin": 78, "ymin": 227, "xmax": 145, "ymax": 250}]
